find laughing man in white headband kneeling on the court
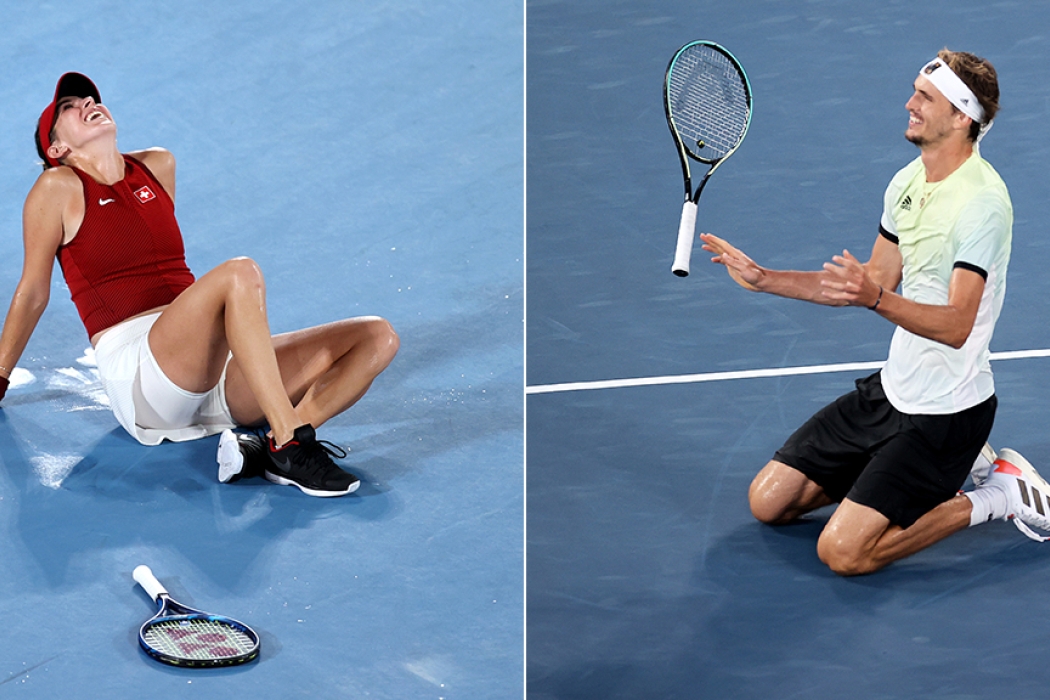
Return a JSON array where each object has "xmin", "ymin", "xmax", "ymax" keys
[{"xmin": 700, "ymin": 49, "xmax": 1050, "ymax": 575}]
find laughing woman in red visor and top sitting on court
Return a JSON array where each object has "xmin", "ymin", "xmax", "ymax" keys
[{"xmin": 0, "ymin": 72, "xmax": 398, "ymax": 496}]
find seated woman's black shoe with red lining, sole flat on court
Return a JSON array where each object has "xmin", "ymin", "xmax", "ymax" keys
[{"xmin": 266, "ymin": 424, "xmax": 361, "ymax": 497}]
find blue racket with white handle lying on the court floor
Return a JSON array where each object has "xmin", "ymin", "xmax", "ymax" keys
[{"xmin": 131, "ymin": 565, "xmax": 259, "ymax": 667}]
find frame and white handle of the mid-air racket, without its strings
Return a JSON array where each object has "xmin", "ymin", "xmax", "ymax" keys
[{"xmin": 664, "ymin": 40, "xmax": 752, "ymax": 277}]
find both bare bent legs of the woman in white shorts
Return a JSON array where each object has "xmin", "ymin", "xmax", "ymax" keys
[{"xmin": 143, "ymin": 258, "xmax": 399, "ymax": 445}]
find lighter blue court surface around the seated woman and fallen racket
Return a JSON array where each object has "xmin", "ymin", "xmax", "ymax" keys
[{"xmin": 0, "ymin": 0, "xmax": 524, "ymax": 700}]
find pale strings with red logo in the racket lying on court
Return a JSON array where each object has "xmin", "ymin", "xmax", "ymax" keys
[{"xmin": 142, "ymin": 618, "xmax": 256, "ymax": 661}]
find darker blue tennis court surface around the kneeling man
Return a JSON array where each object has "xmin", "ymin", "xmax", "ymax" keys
[{"xmin": 526, "ymin": 0, "xmax": 1050, "ymax": 700}]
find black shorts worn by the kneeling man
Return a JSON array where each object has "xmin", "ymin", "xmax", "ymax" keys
[{"xmin": 774, "ymin": 373, "xmax": 999, "ymax": 528}]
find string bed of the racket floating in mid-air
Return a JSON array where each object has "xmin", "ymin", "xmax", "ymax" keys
[{"xmin": 668, "ymin": 45, "xmax": 751, "ymax": 161}]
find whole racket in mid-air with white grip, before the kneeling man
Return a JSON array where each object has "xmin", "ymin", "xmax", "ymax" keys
[{"xmin": 664, "ymin": 41, "xmax": 751, "ymax": 277}]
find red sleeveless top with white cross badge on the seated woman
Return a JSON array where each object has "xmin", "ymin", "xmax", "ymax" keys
[{"xmin": 58, "ymin": 155, "xmax": 194, "ymax": 337}]
